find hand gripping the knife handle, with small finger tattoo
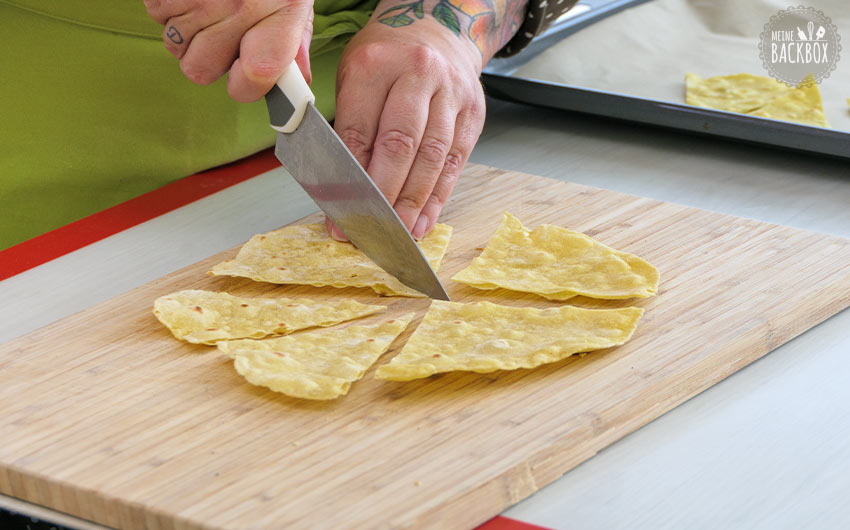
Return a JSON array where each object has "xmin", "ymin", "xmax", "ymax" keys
[{"xmin": 145, "ymin": 0, "xmax": 313, "ymax": 102}]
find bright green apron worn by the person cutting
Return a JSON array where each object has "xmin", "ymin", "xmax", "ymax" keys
[{"xmin": 0, "ymin": 0, "xmax": 377, "ymax": 250}]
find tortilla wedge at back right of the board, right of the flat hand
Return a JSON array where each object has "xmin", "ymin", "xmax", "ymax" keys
[{"xmin": 452, "ymin": 213, "xmax": 658, "ymax": 300}]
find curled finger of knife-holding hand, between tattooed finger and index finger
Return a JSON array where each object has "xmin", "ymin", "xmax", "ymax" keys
[{"xmin": 180, "ymin": 19, "xmax": 247, "ymax": 85}]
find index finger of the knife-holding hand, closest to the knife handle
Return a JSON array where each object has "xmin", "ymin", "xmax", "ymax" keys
[{"xmin": 227, "ymin": 4, "xmax": 310, "ymax": 103}]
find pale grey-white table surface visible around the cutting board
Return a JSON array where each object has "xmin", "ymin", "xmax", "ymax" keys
[{"xmin": 0, "ymin": 100, "xmax": 850, "ymax": 529}]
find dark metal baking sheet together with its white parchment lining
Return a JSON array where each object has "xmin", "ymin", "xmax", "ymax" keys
[{"xmin": 482, "ymin": 0, "xmax": 850, "ymax": 158}]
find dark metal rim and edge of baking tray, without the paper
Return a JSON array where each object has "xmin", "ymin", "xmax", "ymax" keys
[{"xmin": 482, "ymin": 0, "xmax": 850, "ymax": 159}]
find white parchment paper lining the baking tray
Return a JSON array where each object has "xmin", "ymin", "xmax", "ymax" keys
[{"xmin": 513, "ymin": 0, "xmax": 850, "ymax": 132}]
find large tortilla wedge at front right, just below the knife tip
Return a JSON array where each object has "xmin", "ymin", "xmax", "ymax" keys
[{"xmin": 375, "ymin": 300, "xmax": 643, "ymax": 381}]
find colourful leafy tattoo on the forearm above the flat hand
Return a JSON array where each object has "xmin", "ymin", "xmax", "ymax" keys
[{"xmin": 377, "ymin": 0, "xmax": 528, "ymax": 59}]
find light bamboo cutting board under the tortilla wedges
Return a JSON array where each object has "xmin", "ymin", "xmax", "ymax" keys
[{"xmin": 0, "ymin": 166, "xmax": 850, "ymax": 529}]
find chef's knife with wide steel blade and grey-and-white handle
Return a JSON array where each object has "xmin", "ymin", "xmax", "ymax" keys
[{"xmin": 266, "ymin": 62, "xmax": 449, "ymax": 300}]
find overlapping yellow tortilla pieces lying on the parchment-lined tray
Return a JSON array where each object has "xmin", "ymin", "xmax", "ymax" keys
[{"xmin": 685, "ymin": 74, "xmax": 829, "ymax": 127}]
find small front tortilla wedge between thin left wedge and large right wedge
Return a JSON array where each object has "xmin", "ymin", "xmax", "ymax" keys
[{"xmin": 218, "ymin": 313, "xmax": 413, "ymax": 400}]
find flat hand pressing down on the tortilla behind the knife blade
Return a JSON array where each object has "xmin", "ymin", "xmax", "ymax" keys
[{"xmin": 327, "ymin": 19, "xmax": 484, "ymax": 240}]
